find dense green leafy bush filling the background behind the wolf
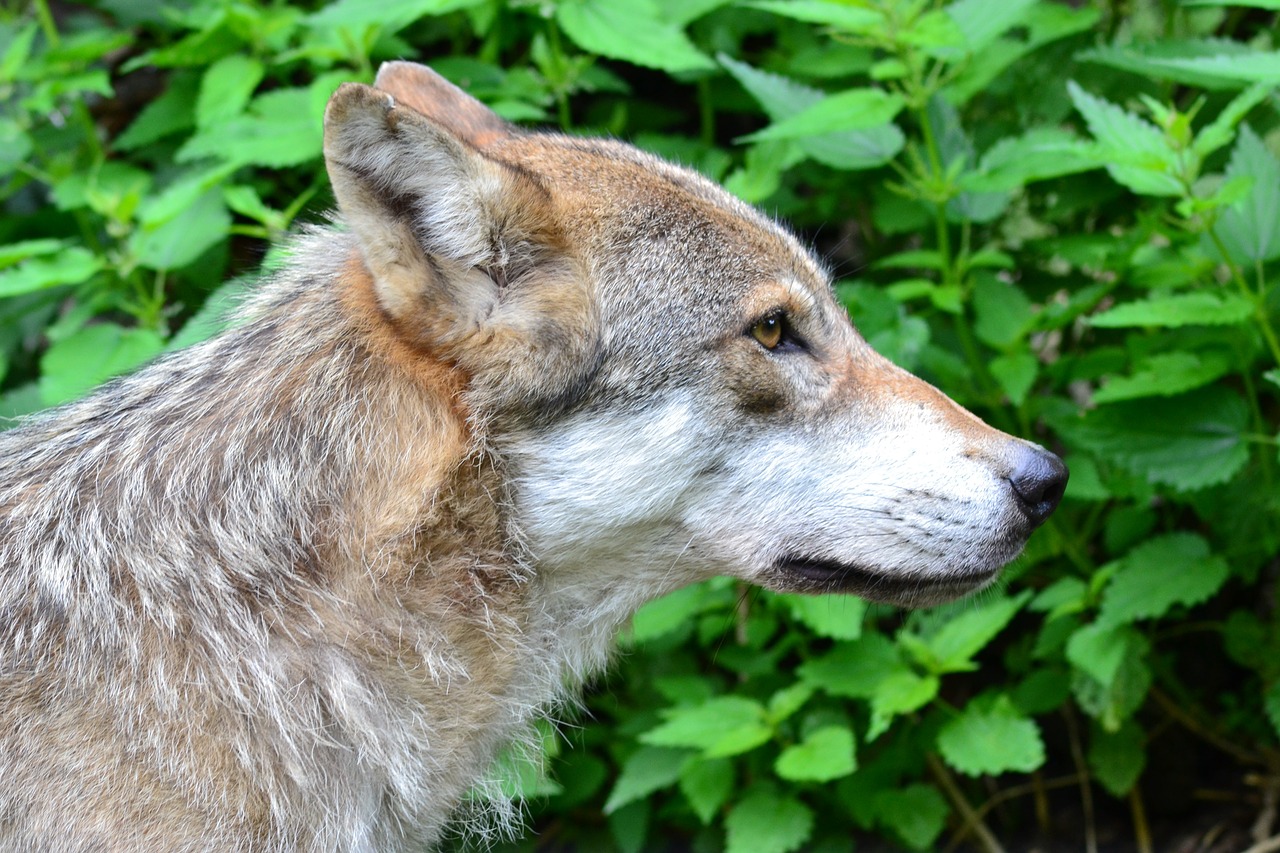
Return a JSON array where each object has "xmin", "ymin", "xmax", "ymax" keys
[{"xmin": 0, "ymin": 0, "xmax": 1280, "ymax": 853}]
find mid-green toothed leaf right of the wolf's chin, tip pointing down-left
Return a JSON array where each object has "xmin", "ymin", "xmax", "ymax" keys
[{"xmin": 1097, "ymin": 533, "xmax": 1230, "ymax": 626}]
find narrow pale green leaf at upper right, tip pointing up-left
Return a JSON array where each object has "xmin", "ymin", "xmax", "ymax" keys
[{"xmin": 1066, "ymin": 81, "xmax": 1185, "ymax": 196}]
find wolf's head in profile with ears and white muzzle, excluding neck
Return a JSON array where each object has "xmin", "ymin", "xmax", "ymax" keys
[{"xmin": 325, "ymin": 63, "xmax": 1066, "ymax": 607}]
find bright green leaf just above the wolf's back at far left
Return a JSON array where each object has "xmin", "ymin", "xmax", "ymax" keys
[{"xmin": 40, "ymin": 323, "xmax": 164, "ymax": 406}]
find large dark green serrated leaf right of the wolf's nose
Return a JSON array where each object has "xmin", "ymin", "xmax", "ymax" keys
[{"xmin": 1059, "ymin": 386, "xmax": 1249, "ymax": 491}]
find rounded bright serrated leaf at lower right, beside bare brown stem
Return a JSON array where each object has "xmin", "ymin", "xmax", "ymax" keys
[{"xmin": 938, "ymin": 695, "xmax": 1044, "ymax": 776}]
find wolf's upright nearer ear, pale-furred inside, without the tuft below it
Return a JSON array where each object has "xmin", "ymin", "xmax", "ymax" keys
[{"xmin": 324, "ymin": 78, "xmax": 548, "ymax": 345}]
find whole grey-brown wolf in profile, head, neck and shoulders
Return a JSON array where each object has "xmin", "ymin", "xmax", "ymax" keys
[{"xmin": 0, "ymin": 63, "xmax": 1066, "ymax": 850}]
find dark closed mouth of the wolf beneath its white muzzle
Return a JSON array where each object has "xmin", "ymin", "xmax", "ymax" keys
[{"xmin": 777, "ymin": 557, "xmax": 1000, "ymax": 605}]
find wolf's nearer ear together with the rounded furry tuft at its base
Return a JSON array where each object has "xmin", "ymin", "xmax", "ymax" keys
[{"xmin": 324, "ymin": 81, "xmax": 599, "ymax": 410}]
